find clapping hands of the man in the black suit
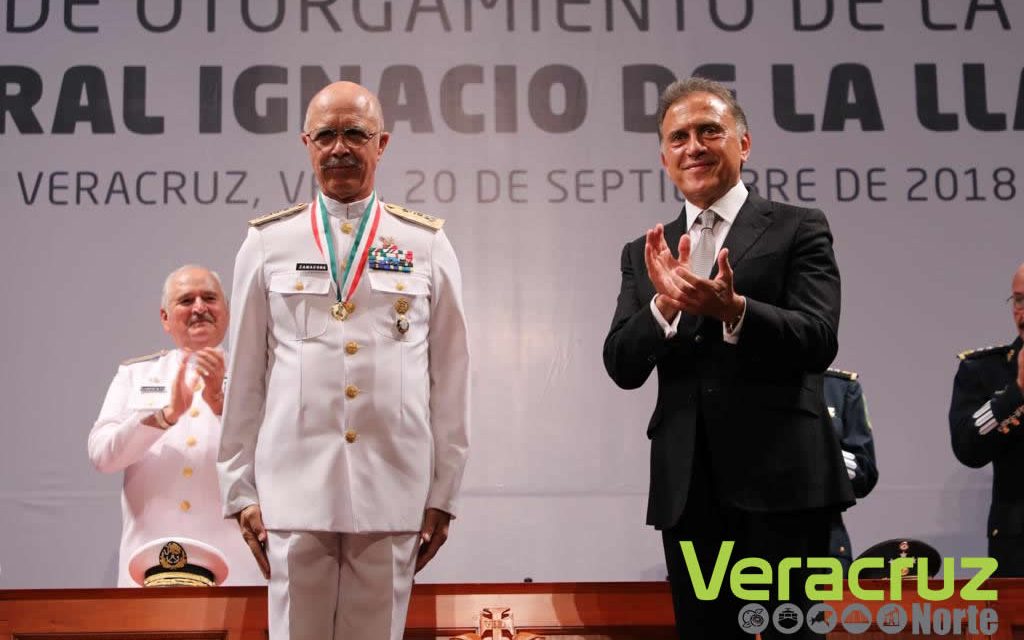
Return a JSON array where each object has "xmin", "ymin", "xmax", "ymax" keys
[{"xmin": 644, "ymin": 224, "xmax": 743, "ymax": 322}]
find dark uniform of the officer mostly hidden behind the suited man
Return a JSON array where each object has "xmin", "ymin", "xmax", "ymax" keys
[{"xmin": 824, "ymin": 369, "xmax": 879, "ymax": 567}]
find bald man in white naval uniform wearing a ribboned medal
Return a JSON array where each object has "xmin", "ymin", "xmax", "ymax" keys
[{"xmin": 218, "ymin": 82, "xmax": 469, "ymax": 640}]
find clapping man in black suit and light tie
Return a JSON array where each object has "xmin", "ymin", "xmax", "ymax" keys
[{"xmin": 604, "ymin": 78, "xmax": 853, "ymax": 639}]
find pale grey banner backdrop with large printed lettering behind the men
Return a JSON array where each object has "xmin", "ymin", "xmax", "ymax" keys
[{"xmin": 0, "ymin": 0, "xmax": 1024, "ymax": 588}]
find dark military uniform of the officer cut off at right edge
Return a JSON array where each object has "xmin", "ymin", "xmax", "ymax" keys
[{"xmin": 949, "ymin": 338, "xmax": 1024, "ymax": 575}]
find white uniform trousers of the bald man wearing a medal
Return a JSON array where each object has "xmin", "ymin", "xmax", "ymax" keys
[{"xmin": 267, "ymin": 530, "xmax": 420, "ymax": 640}]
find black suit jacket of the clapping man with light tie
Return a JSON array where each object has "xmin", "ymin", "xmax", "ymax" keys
[{"xmin": 604, "ymin": 194, "xmax": 854, "ymax": 528}]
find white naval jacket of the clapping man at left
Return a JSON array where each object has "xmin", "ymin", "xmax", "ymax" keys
[{"xmin": 89, "ymin": 349, "xmax": 266, "ymax": 587}]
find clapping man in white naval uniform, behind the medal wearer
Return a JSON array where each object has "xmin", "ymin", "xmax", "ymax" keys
[{"xmin": 88, "ymin": 265, "xmax": 266, "ymax": 587}]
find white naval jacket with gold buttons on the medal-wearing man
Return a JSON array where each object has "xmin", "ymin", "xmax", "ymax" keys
[{"xmin": 218, "ymin": 197, "xmax": 469, "ymax": 534}]
